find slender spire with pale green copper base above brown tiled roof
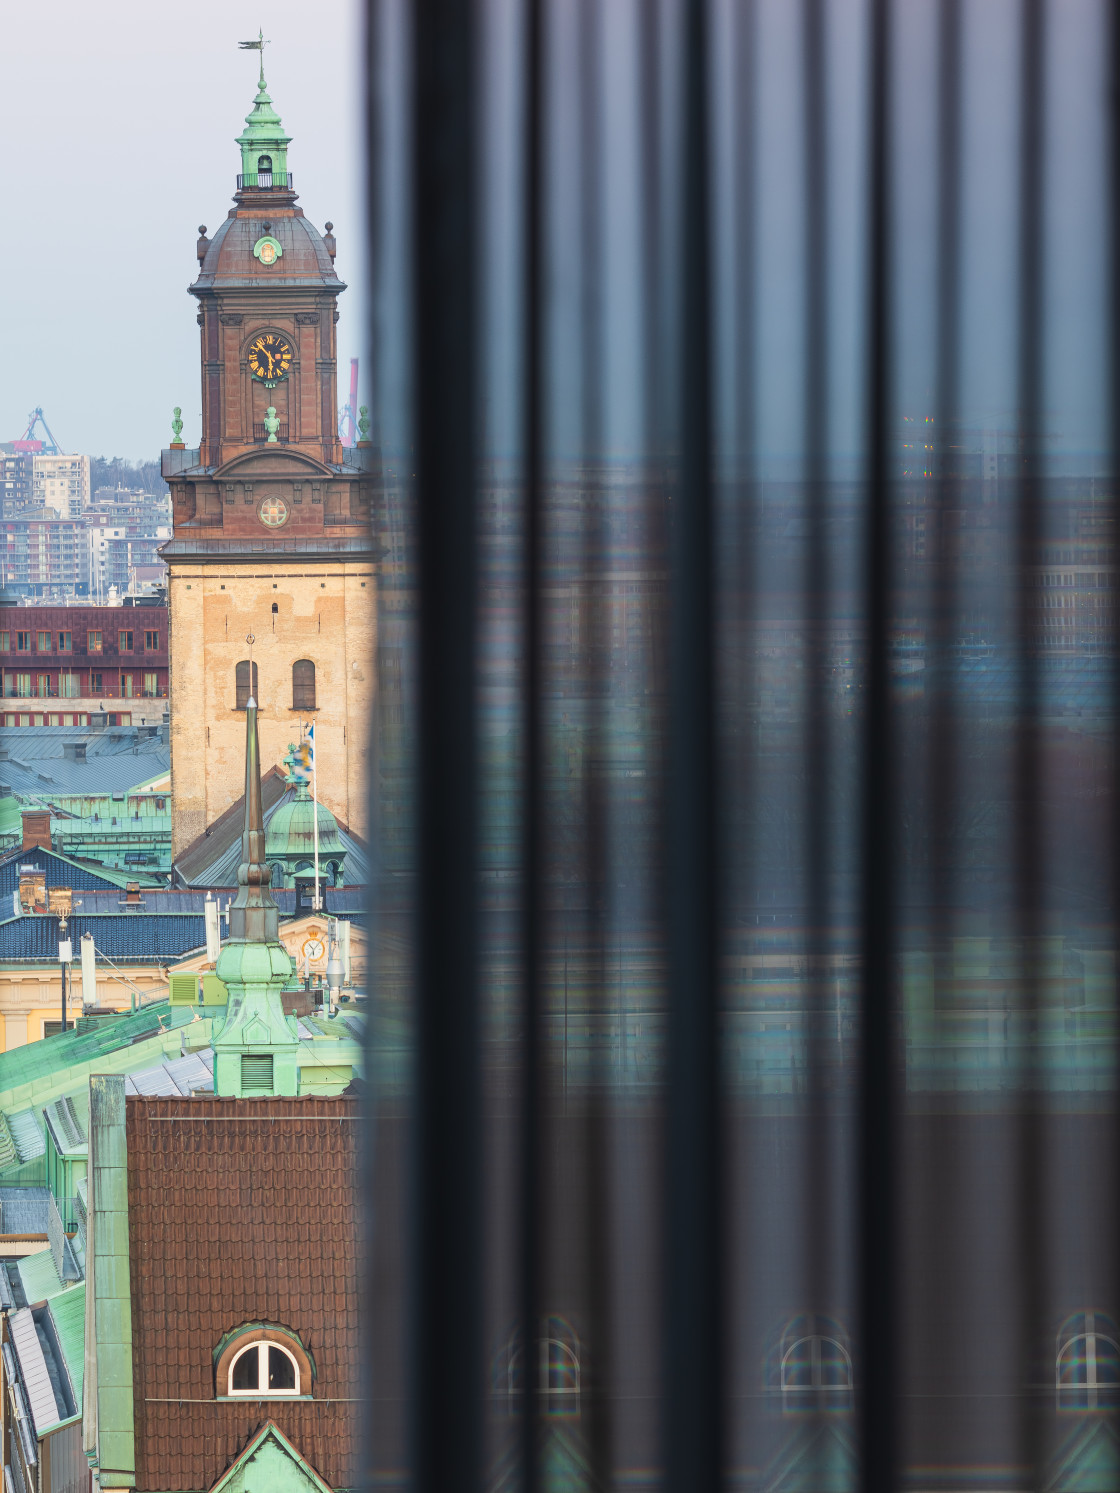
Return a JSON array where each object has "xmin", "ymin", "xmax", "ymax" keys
[{"xmin": 214, "ymin": 686, "xmax": 299, "ymax": 1099}]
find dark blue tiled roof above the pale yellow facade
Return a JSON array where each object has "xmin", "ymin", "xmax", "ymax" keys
[{"xmin": 0, "ymin": 912, "xmax": 206, "ymax": 964}]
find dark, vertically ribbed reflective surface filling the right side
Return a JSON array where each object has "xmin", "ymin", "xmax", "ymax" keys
[{"xmin": 363, "ymin": 0, "xmax": 1120, "ymax": 1493}]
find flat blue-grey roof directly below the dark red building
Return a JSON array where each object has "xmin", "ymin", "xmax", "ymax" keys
[{"xmin": 0, "ymin": 725, "xmax": 172, "ymax": 799}]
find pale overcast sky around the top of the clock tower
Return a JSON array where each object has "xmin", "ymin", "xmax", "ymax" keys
[{"xmin": 0, "ymin": 0, "xmax": 366, "ymax": 460}]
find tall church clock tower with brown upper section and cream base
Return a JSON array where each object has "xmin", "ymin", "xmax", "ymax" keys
[{"xmin": 163, "ymin": 49, "xmax": 376, "ymax": 855}]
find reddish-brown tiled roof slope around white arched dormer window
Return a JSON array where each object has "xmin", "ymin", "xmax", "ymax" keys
[{"xmin": 125, "ymin": 1096, "xmax": 358, "ymax": 1493}]
